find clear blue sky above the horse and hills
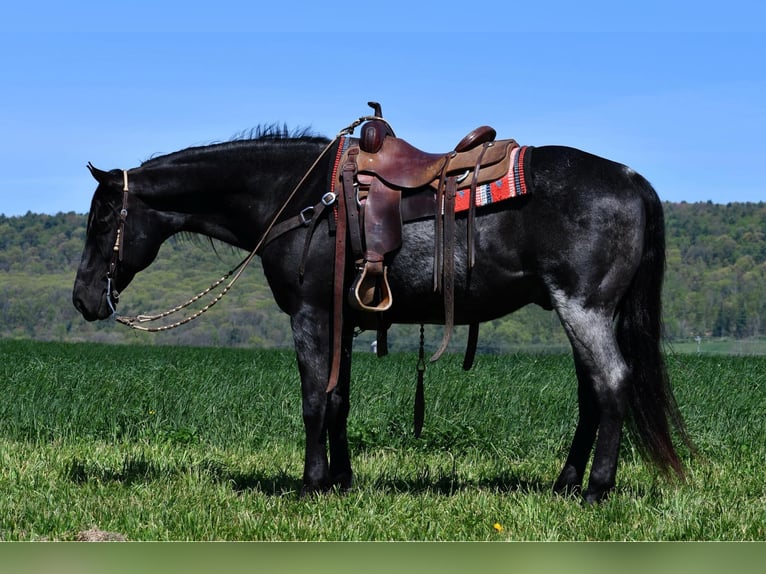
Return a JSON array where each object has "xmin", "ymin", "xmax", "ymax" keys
[{"xmin": 0, "ymin": 0, "xmax": 766, "ymax": 215}]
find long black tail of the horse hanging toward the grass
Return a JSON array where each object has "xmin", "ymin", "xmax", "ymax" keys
[{"xmin": 617, "ymin": 174, "xmax": 693, "ymax": 477}]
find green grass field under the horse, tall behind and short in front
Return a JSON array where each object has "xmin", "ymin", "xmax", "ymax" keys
[{"xmin": 0, "ymin": 341, "xmax": 766, "ymax": 540}]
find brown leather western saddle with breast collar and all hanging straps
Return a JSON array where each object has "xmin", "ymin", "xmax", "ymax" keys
[{"xmin": 263, "ymin": 102, "xmax": 519, "ymax": 418}]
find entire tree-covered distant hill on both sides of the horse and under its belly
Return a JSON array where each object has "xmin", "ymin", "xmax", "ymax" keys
[{"xmin": 0, "ymin": 202, "xmax": 766, "ymax": 352}]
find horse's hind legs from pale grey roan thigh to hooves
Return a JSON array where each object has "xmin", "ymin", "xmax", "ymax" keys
[{"xmin": 555, "ymin": 301, "xmax": 629, "ymax": 503}]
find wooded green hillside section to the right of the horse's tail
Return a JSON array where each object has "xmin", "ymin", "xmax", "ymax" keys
[{"xmin": 665, "ymin": 202, "xmax": 766, "ymax": 338}]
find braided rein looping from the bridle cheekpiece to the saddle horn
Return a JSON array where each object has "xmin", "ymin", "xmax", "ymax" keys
[{"xmin": 111, "ymin": 116, "xmax": 380, "ymax": 333}]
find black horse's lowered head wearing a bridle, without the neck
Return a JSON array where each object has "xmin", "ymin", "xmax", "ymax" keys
[{"xmin": 72, "ymin": 164, "xmax": 167, "ymax": 321}]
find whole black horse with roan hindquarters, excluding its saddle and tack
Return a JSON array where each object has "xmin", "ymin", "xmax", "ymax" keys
[{"xmin": 73, "ymin": 125, "xmax": 690, "ymax": 502}]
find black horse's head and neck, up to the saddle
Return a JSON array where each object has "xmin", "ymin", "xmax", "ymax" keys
[{"xmin": 72, "ymin": 132, "xmax": 329, "ymax": 321}]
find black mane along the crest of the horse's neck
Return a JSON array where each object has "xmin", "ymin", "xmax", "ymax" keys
[{"xmin": 141, "ymin": 124, "xmax": 329, "ymax": 167}]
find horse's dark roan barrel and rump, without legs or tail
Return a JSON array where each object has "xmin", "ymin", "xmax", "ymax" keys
[{"xmin": 390, "ymin": 142, "xmax": 658, "ymax": 323}]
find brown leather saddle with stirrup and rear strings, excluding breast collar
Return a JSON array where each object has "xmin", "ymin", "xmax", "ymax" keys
[{"xmin": 339, "ymin": 104, "xmax": 518, "ymax": 361}]
